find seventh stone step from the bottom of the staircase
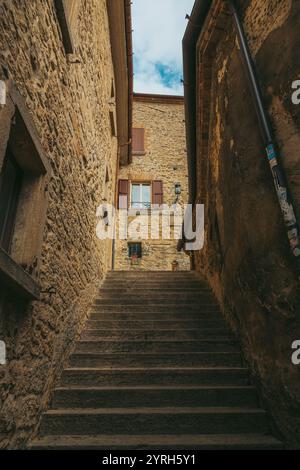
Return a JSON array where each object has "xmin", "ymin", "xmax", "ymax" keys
[{"xmin": 81, "ymin": 328, "xmax": 230, "ymax": 341}]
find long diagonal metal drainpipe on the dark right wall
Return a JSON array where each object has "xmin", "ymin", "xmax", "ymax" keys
[{"xmin": 227, "ymin": 0, "xmax": 300, "ymax": 278}]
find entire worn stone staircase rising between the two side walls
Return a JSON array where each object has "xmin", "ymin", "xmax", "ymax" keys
[{"xmin": 31, "ymin": 272, "xmax": 282, "ymax": 450}]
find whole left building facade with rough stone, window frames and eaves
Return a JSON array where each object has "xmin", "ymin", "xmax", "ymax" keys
[{"xmin": 0, "ymin": 0, "xmax": 132, "ymax": 448}]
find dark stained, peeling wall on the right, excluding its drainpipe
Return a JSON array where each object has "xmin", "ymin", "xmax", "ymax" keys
[{"xmin": 195, "ymin": 0, "xmax": 300, "ymax": 448}]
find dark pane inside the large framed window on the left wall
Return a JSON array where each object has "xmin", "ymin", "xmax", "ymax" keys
[{"xmin": 0, "ymin": 150, "xmax": 23, "ymax": 253}]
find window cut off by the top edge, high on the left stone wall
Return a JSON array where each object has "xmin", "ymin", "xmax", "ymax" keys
[{"xmin": 55, "ymin": 0, "xmax": 81, "ymax": 54}]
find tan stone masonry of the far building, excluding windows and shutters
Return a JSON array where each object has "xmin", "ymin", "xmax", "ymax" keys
[{"xmin": 115, "ymin": 100, "xmax": 190, "ymax": 271}]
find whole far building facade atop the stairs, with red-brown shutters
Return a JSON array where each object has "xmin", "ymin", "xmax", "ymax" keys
[{"xmin": 114, "ymin": 94, "xmax": 190, "ymax": 271}]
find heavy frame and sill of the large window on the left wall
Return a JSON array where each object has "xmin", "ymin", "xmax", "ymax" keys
[{"xmin": 0, "ymin": 80, "xmax": 52, "ymax": 300}]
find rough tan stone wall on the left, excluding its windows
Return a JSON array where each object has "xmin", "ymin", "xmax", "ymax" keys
[{"xmin": 0, "ymin": 0, "xmax": 117, "ymax": 448}]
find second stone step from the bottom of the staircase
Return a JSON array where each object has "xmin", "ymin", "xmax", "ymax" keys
[{"xmin": 40, "ymin": 407, "xmax": 269, "ymax": 436}]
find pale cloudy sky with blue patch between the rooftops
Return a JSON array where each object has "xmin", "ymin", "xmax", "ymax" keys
[{"xmin": 132, "ymin": 0, "xmax": 194, "ymax": 95}]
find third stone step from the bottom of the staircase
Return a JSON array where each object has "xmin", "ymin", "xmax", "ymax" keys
[{"xmin": 52, "ymin": 385, "xmax": 258, "ymax": 409}]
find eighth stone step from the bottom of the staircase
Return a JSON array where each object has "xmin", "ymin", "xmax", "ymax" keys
[{"xmin": 86, "ymin": 317, "xmax": 228, "ymax": 331}]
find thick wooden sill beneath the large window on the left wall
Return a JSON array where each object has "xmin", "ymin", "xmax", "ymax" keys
[{"xmin": 0, "ymin": 248, "xmax": 40, "ymax": 300}]
